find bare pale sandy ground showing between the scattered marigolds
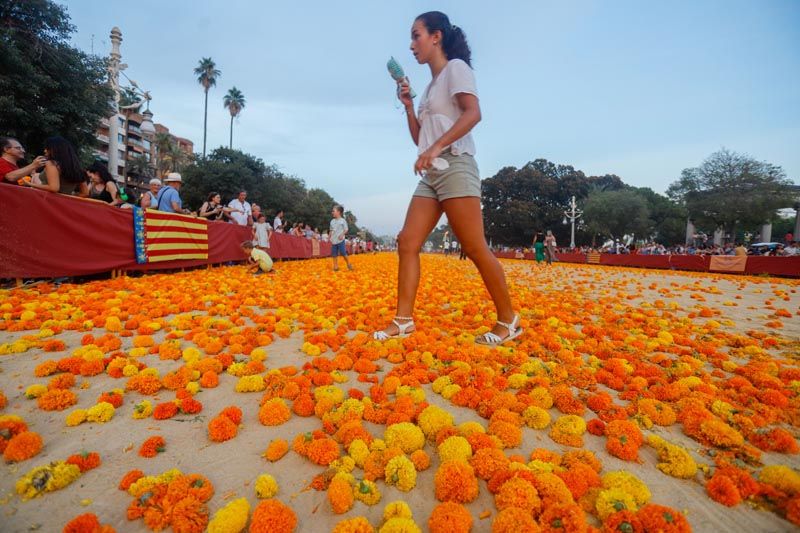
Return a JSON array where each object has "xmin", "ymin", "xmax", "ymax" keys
[{"xmin": 0, "ymin": 257, "xmax": 800, "ymax": 532}]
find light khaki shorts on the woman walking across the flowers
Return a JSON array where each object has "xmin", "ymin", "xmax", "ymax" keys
[{"xmin": 414, "ymin": 150, "xmax": 481, "ymax": 202}]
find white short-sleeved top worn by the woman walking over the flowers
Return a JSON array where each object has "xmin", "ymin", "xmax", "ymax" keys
[{"xmin": 417, "ymin": 59, "xmax": 478, "ymax": 155}]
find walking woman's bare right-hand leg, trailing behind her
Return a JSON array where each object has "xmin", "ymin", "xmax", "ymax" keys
[{"xmin": 442, "ymin": 196, "xmax": 514, "ymax": 338}]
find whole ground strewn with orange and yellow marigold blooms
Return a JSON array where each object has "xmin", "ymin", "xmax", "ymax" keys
[{"xmin": 0, "ymin": 254, "xmax": 800, "ymax": 532}]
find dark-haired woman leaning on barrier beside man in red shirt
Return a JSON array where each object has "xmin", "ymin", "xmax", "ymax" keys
[{"xmin": 23, "ymin": 136, "xmax": 89, "ymax": 198}]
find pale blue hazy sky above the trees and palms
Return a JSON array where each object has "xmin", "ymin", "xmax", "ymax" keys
[{"xmin": 61, "ymin": 0, "xmax": 800, "ymax": 234}]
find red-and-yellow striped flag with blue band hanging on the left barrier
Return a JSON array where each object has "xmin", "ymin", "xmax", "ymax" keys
[{"xmin": 133, "ymin": 207, "xmax": 208, "ymax": 264}]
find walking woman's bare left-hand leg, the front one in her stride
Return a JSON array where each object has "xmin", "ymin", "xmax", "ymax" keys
[{"xmin": 383, "ymin": 196, "xmax": 442, "ymax": 335}]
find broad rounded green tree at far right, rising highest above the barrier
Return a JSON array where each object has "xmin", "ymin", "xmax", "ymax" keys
[{"xmin": 667, "ymin": 148, "xmax": 792, "ymax": 241}]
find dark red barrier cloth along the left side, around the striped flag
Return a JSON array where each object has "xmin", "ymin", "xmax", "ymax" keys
[{"xmin": 0, "ymin": 183, "xmax": 330, "ymax": 278}]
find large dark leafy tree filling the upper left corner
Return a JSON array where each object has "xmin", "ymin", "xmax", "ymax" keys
[{"xmin": 0, "ymin": 0, "xmax": 112, "ymax": 155}]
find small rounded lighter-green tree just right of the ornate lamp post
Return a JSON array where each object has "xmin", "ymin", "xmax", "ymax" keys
[{"xmin": 583, "ymin": 188, "xmax": 652, "ymax": 239}]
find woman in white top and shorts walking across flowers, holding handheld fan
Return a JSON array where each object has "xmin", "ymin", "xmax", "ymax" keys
[{"xmin": 373, "ymin": 11, "xmax": 522, "ymax": 346}]
